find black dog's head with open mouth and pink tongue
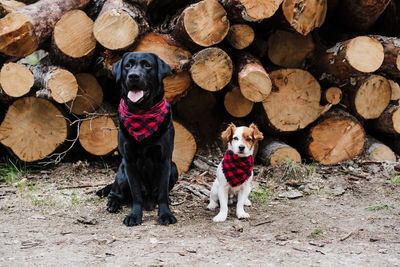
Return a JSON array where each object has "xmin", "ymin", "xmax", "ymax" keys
[{"xmin": 111, "ymin": 52, "xmax": 171, "ymax": 111}]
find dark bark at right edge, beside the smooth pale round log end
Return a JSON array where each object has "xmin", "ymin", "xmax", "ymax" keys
[{"xmin": 373, "ymin": 35, "xmax": 400, "ymax": 79}]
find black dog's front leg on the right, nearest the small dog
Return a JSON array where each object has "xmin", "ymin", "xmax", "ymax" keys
[{"xmin": 157, "ymin": 162, "xmax": 177, "ymax": 225}]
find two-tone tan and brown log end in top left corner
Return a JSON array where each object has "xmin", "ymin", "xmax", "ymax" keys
[{"xmin": 0, "ymin": 12, "xmax": 38, "ymax": 57}]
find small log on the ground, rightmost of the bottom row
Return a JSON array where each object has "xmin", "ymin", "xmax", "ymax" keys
[{"xmin": 364, "ymin": 136, "xmax": 396, "ymax": 162}]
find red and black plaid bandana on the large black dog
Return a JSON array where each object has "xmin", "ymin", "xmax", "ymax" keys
[{"xmin": 118, "ymin": 96, "xmax": 169, "ymax": 142}]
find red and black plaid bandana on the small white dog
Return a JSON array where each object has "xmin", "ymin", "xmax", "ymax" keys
[{"xmin": 222, "ymin": 150, "xmax": 254, "ymax": 187}]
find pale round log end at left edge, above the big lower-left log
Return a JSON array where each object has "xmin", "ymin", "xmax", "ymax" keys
[{"xmin": 0, "ymin": 63, "xmax": 34, "ymax": 97}]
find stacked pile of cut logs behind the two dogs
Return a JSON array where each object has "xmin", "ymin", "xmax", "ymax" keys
[{"xmin": 0, "ymin": 0, "xmax": 400, "ymax": 173}]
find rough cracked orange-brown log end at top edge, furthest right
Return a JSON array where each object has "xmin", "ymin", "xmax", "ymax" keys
[{"xmin": 282, "ymin": 0, "xmax": 328, "ymax": 36}]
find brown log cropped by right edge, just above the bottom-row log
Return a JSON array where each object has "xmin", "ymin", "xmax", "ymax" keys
[{"xmin": 369, "ymin": 105, "xmax": 400, "ymax": 135}]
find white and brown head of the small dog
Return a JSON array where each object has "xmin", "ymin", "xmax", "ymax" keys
[{"xmin": 221, "ymin": 123, "xmax": 264, "ymax": 157}]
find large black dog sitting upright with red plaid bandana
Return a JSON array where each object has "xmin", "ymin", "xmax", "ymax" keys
[{"xmin": 97, "ymin": 52, "xmax": 178, "ymax": 226}]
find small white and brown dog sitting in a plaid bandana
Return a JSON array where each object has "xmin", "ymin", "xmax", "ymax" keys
[{"xmin": 207, "ymin": 123, "xmax": 264, "ymax": 222}]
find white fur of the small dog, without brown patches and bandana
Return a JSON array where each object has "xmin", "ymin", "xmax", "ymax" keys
[{"xmin": 207, "ymin": 126, "xmax": 254, "ymax": 222}]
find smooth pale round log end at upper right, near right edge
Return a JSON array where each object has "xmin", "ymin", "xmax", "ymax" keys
[{"xmin": 345, "ymin": 36, "xmax": 385, "ymax": 72}]
